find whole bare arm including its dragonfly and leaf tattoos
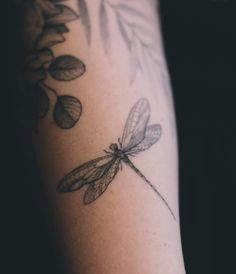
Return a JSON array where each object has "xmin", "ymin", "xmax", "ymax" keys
[{"xmin": 18, "ymin": 0, "xmax": 184, "ymax": 274}]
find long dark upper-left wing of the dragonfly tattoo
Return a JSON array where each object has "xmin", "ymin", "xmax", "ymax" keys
[{"xmin": 57, "ymin": 155, "xmax": 112, "ymax": 192}]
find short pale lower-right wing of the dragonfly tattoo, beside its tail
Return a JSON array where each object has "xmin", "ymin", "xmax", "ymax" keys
[{"xmin": 127, "ymin": 124, "xmax": 162, "ymax": 155}]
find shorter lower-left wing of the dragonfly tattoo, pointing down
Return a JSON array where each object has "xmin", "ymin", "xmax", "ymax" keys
[{"xmin": 84, "ymin": 158, "xmax": 120, "ymax": 205}]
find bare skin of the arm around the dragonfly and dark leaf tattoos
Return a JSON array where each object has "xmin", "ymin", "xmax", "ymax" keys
[{"xmin": 18, "ymin": 0, "xmax": 185, "ymax": 274}]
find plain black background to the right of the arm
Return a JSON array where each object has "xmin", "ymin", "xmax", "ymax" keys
[{"xmin": 161, "ymin": 0, "xmax": 236, "ymax": 274}]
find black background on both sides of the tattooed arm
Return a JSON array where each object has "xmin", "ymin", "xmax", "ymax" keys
[{"xmin": 1, "ymin": 0, "xmax": 236, "ymax": 274}]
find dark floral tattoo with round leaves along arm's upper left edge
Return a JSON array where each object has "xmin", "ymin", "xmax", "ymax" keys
[{"xmin": 17, "ymin": 0, "xmax": 86, "ymax": 129}]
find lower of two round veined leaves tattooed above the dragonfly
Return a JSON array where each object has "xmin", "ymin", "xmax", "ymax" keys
[{"xmin": 53, "ymin": 95, "xmax": 82, "ymax": 129}]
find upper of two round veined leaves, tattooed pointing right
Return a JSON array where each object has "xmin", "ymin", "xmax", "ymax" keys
[{"xmin": 48, "ymin": 55, "xmax": 85, "ymax": 81}]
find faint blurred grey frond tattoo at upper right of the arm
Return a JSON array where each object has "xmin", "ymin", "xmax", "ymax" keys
[{"xmin": 99, "ymin": 0, "xmax": 160, "ymax": 83}]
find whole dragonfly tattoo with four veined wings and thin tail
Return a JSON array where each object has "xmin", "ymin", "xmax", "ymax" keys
[{"xmin": 57, "ymin": 98, "xmax": 176, "ymax": 220}]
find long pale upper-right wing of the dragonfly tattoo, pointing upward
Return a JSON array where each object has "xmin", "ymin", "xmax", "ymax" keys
[{"xmin": 121, "ymin": 98, "xmax": 150, "ymax": 150}]
